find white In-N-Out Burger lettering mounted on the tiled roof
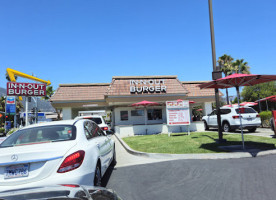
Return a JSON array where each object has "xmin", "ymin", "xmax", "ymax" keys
[{"xmin": 129, "ymin": 79, "xmax": 167, "ymax": 93}]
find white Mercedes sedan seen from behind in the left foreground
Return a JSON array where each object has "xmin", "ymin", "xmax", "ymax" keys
[{"xmin": 0, "ymin": 119, "xmax": 116, "ymax": 191}]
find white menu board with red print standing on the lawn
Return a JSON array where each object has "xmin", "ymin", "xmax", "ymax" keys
[{"xmin": 166, "ymin": 101, "xmax": 190, "ymax": 126}]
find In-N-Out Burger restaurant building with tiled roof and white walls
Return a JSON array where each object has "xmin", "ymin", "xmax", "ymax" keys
[{"xmin": 51, "ymin": 76, "xmax": 220, "ymax": 137}]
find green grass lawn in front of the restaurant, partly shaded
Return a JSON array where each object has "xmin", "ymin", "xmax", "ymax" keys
[{"xmin": 123, "ymin": 132, "xmax": 276, "ymax": 154}]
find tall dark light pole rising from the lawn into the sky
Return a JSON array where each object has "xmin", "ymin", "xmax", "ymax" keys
[{"xmin": 208, "ymin": 0, "xmax": 225, "ymax": 143}]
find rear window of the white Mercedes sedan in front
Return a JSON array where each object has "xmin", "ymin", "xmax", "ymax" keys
[{"xmin": 0, "ymin": 125, "xmax": 76, "ymax": 147}]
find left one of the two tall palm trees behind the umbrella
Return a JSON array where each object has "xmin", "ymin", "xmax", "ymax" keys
[{"xmin": 218, "ymin": 54, "xmax": 234, "ymax": 104}]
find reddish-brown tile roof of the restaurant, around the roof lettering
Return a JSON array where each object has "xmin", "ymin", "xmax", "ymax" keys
[{"xmin": 50, "ymin": 76, "xmax": 222, "ymax": 102}]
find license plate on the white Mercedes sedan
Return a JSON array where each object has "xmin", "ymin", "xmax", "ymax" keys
[{"xmin": 4, "ymin": 164, "xmax": 29, "ymax": 179}]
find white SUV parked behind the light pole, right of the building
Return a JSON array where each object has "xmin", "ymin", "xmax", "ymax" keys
[{"xmin": 202, "ymin": 106, "xmax": 261, "ymax": 132}]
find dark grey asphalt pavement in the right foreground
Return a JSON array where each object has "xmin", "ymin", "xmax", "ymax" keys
[{"xmin": 106, "ymin": 155, "xmax": 276, "ymax": 200}]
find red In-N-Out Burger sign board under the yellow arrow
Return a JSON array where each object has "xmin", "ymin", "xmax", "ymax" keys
[{"xmin": 7, "ymin": 82, "xmax": 46, "ymax": 96}]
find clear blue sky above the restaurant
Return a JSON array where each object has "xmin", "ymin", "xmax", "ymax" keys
[{"xmin": 0, "ymin": 0, "xmax": 276, "ymax": 94}]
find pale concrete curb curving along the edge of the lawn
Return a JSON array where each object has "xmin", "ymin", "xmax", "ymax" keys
[{"xmin": 114, "ymin": 133, "xmax": 276, "ymax": 160}]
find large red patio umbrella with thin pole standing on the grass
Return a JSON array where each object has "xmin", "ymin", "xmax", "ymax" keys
[{"xmin": 199, "ymin": 74, "xmax": 276, "ymax": 149}]
